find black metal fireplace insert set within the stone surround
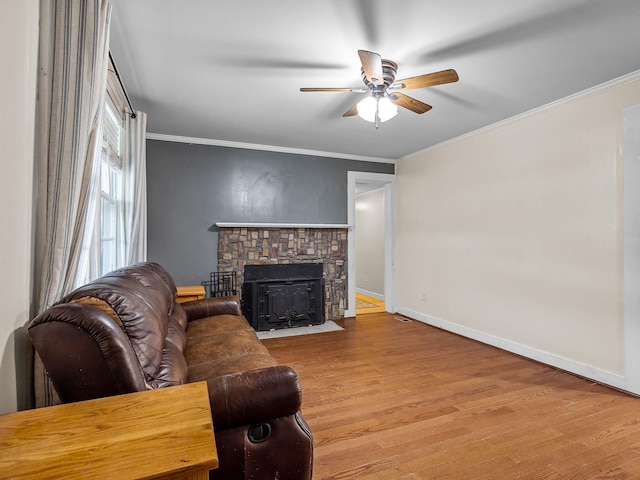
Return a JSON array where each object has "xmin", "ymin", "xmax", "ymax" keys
[{"xmin": 242, "ymin": 263, "xmax": 324, "ymax": 331}]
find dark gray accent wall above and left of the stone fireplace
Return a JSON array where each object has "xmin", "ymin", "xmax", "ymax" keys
[{"xmin": 147, "ymin": 140, "xmax": 395, "ymax": 285}]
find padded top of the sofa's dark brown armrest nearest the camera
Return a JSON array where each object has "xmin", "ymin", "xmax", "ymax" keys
[{"xmin": 207, "ymin": 366, "xmax": 302, "ymax": 430}]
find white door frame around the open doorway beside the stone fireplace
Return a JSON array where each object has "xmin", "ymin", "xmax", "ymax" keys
[{"xmin": 344, "ymin": 171, "xmax": 396, "ymax": 317}]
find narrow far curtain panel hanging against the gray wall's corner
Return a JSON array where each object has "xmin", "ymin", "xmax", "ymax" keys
[{"xmin": 123, "ymin": 112, "xmax": 147, "ymax": 265}]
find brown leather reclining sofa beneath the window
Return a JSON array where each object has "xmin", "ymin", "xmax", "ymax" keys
[{"xmin": 28, "ymin": 263, "xmax": 313, "ymax": 480}]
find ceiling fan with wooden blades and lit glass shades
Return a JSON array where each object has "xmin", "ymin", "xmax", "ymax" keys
[{"xmin": 300, "ymin": 50, "xmax": 458, "ymax": 128}]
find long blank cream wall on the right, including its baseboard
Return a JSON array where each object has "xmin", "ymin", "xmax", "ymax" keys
[{"xmin": 396, "ymin": 75, "xmax": 640, "ymax": 393}]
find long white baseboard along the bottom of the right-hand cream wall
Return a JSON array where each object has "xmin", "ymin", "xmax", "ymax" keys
[{"xmin": 398, "ymin": 307, "xmax": 640, "ymax": 395}]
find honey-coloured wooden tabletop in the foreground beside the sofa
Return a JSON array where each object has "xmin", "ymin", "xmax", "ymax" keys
[{"xmin": 0, "ymin": 382, "xmax": 218, "ymax": 480}]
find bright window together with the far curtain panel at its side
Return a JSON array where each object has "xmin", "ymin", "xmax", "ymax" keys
[{"xmin": 78, "ymin": 53, "xmax": 146, "ymax": 285}]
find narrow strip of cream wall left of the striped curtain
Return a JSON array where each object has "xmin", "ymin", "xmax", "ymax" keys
[{"xmin": 0, "ymin": 0, "xmax": 39, "ymax": 413}]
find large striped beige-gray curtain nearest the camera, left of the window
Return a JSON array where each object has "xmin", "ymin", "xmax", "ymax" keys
[{"xmin": 34, "ymin": 0, "xmax": 111, "ymax": 312}]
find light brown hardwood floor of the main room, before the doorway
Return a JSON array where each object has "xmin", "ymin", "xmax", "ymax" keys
[{"xmin": 264, "ymin": 313, "xmax": 640, "ymax": 480}]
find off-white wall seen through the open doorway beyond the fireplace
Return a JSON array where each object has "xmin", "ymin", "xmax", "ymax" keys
[{"xmin": 356, "ymin": 188, "xmax": 385, "ymax": 299}]
